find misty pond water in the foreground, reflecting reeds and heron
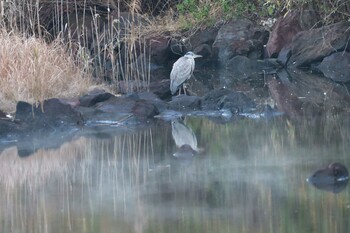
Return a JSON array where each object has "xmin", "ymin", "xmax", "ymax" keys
[{"xmin": 0, "ymin": 116, "xmax": 350, "ymax": 233}]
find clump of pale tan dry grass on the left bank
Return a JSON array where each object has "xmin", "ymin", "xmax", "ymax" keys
[{"xmin": 0, "ymin": 31, "xmax": 93, "ymax": 112}]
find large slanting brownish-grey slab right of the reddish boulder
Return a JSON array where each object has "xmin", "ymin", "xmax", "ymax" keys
[{"xmin": 281, "ymin": 21, "xmax": 350, "ymax": 67}]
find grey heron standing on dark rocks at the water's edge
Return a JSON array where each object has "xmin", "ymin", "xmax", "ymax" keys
[{"xmin": 170, "ymin": 52, "xmax": 202, "ymax": 95}]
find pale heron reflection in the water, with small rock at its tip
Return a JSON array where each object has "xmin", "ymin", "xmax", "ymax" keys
[{"xmin": 171, "ymin": 119, "xmax": 203, "ymax": 159}]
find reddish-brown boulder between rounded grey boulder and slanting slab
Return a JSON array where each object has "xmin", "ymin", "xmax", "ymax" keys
[{"xmin": 266, "ymin": 10, "xmax": 317, "ymax": 57}]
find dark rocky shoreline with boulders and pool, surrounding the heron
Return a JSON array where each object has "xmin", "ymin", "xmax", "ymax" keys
[{"xmin": 0, "ymin": 11, "xmax": 350, "ymax": 156}]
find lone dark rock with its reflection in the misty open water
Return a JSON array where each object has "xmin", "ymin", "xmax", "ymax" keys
[{"xmin": 306, "ymin": 163, "xmax": 349, "ymax": 193}]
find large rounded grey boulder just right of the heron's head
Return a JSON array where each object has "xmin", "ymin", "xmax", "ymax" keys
[{"xmin": 213, "ymin": 19, "xmax": 268, "ymax": 62}]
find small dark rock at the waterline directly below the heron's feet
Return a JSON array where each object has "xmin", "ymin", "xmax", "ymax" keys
[{"xmin": 169, "ymin": 95, "xmax": 201, "ymax": 111}]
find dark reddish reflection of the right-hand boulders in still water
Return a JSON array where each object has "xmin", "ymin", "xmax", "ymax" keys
[{"xmin": 267, "ymin": 70, "xmax": 350, "ymax": 118}]
